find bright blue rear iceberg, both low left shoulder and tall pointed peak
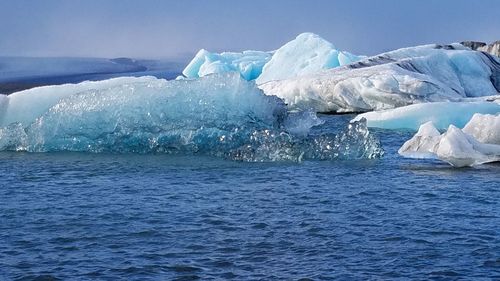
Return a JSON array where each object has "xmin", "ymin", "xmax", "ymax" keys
[{"xmin": 182, "ymin": 33, "xmax": 362, "ymax": 83}]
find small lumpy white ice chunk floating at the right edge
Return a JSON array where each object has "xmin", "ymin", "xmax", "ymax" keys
[{"xmin": 398, "ymin": 114, "xmax": 500, "ymax": 167}]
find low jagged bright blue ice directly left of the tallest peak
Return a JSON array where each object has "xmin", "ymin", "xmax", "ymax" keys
[{"xmin": 182, "ymin": 49, "xmax": 271, "ymax": 80}]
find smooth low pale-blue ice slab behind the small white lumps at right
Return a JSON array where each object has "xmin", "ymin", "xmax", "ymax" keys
[{"xmin": 354, "ymin": 101, "xmax": 500, "ymax": 130}]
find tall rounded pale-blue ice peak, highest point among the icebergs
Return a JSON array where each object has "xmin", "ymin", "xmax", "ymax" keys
[{"xmin": 256, "ymin": 33, "xmax": 361, "ymax": 84}]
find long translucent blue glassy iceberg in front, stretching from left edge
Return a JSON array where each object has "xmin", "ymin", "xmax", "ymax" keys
[{"xmin": 0, "ymin": 73, "xmax": 382, "ymax": 161}]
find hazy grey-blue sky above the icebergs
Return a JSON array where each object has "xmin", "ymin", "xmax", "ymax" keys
[{"xmin": 0, "ymin": 0, "xmax": 500, "ymax": 58}]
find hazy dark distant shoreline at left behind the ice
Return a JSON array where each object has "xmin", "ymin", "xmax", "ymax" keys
[{"xmin": 0, "ymin": 57, "xmax": 185, "ymax": 95}]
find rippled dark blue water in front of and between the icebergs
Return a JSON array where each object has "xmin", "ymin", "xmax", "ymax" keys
[{"xmin": 0, "ymin": 116, "xmax": 500, "ymax": 280}]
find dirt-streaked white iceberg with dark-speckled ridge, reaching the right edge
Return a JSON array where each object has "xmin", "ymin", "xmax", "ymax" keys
[{"xmin": 259, "ymin": 44, "xmax": 500, "ymax": 113}]
